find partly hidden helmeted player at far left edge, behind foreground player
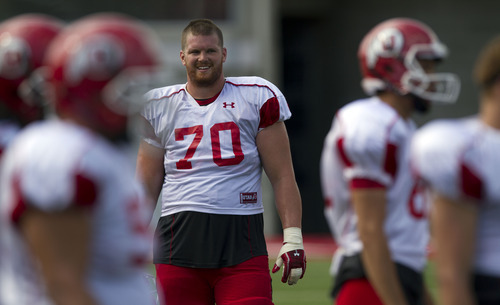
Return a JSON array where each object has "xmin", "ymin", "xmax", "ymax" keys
[{"xmin": 0, "ymin": 14, "xmax": 63, "ymax": 304}]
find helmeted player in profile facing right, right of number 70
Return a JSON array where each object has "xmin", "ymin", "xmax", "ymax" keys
[{"xmin": 320, "ymin": 18, "xmax": 459, "ymax": 305}]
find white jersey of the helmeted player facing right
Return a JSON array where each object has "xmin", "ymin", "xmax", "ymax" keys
[{"xmin": 320, "ymin": 97, "xmax": 429, "ymax": 271}]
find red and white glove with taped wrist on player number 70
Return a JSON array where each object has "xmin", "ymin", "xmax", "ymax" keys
[{"xmin": 272, "ymin": 227, "xmax": 307, "ymax": 285}]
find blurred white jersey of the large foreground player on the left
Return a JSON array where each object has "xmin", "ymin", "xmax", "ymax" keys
[{"xmin": 0, "ymin": 121, "xmax": 152, "ymax": 305}]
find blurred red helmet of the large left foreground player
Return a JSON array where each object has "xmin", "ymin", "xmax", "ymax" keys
[{"xmin": 44, "ymin": 13, "xmax": 161, "ymax": 136}]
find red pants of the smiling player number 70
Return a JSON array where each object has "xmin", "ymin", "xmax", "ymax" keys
[{"xmin": 155, "ymin": 256, "xmax": 273, "ymax": 305}]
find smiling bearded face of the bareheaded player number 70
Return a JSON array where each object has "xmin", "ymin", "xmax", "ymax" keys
[{"xmin": 180, "ymin": 33, "xmax": 227, "ymax": 87}]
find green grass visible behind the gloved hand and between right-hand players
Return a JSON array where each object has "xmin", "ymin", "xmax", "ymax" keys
[{"xmin": 270, "ymin": 259, "xmax": 437, "ymax": 305}]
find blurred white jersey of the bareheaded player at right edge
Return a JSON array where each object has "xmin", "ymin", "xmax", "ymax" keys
[{"xmin": 412, "ymin": 117, "xmax": 500, "ymax": 276}]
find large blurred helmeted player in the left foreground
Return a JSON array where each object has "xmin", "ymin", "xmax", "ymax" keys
[{"xmin": 0, "ymin": 14, "xmax": 165, "ymax": 305}]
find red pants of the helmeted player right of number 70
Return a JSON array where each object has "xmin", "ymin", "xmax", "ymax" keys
[{"xmin": 335, "ymin": 279, "xmax": 384, "ymax": 305}]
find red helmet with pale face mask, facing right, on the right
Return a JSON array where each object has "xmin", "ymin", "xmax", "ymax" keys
[{"xmin": 358, "ymin": 18, "xmax": 460, "ymax": 103}]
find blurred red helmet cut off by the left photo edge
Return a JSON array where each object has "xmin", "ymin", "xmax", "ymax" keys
[{"xmin": 0, "ymin": 14, "xmax": 63, "ymax": 124}]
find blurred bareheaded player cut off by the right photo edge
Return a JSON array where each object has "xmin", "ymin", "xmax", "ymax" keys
[{"xmin": 411, "ymin": 37, "xmax": 500, "ymax": 305}]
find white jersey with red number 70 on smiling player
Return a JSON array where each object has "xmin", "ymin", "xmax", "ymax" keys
[{"xmin": 143, "ymin": 77, "xmax": 291, "ymax": 216}]
